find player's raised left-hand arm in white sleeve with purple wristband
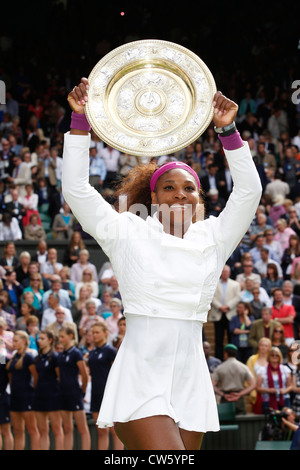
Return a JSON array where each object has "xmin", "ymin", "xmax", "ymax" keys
[{"xmin": 62, "ymin": 78, "xmax": 119, "ymax": 252}]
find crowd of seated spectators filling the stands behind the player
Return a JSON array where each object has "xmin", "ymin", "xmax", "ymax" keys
[{"xmin": 0, "ymin": 0, "xmax": 300, "ymax": 450}]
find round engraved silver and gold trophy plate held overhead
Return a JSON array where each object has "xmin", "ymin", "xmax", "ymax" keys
[{"xmin": 85, "ymin": 39, "xmax": 216, "ymax": 157}]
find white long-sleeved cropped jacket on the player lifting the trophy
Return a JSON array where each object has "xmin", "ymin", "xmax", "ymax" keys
[{"xmin": 62, "ymin": 133, "xmax": 261, "ymax": 322}]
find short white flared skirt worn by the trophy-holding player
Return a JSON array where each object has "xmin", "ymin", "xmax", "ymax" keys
[{"xmin": 97, "ymin": 314, "xmax": 219, "ymax": 432}]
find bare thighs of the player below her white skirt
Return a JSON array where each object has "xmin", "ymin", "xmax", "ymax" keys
[{"xmin": 115, "ymin": 415, "xmax": 203, "ymax": 450}]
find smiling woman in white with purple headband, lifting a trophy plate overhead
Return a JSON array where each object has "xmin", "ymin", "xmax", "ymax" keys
[{"xmin": 62, "ymin": 78, "xmax": 261, "ymax": 450}]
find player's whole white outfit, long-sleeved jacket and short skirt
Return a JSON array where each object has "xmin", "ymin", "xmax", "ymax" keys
[{"xmin": 62, "ymin": 133, "xmax": 261, "ymax": 432}]
